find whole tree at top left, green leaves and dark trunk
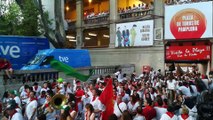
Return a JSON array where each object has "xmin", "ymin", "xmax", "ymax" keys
[{"xmin": 0, "ymin": 0, "xmax": 66, "ymax": 48}]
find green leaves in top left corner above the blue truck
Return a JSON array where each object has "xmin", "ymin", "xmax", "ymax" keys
[{"xmin": 0, "ymin": 0, "xmax": 41, "ymax": 36}]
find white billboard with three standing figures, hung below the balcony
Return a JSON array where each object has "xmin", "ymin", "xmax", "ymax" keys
[{"xmin": 115, "ymin": 20, "xmax": 154, "ymax": 47}]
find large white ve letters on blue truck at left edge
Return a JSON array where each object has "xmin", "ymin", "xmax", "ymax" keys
[{"xmin": 0, "ymin": 45, "xmax": 20, "ymax": 58}]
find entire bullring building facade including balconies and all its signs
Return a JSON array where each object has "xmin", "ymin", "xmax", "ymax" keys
[{"xmin": 64, "ymin": 0, "xmax": 212, "ymax": 74}]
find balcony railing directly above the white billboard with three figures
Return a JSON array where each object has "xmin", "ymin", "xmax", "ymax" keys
[{"xmin": 119, "ymin": 9, "xmax": 153, "ymax": 19}]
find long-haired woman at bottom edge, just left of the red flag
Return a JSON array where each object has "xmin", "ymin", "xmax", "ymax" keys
[{"xmin": 85, "ymin": 103, "xmax": 95, "ymax": 120}]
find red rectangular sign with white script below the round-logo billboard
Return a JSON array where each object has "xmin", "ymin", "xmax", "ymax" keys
[{"xmin": 166, "ymin": 45, "xmax": 211, "ymax": 61}]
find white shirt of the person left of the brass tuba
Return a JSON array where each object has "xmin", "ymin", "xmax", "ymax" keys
[{"xmin": 25, "ymin": 100, "xmax": 38, "ymax": 119}]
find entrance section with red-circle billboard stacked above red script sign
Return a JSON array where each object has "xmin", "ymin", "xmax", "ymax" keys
[{"xmin": 164, "ymin": 1, "xmax": 213, "ymax": 74}]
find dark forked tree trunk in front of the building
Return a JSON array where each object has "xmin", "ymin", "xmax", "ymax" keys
[{"xmin": 16, "ymin": 0, "xmax": 66, "ymax": 48}]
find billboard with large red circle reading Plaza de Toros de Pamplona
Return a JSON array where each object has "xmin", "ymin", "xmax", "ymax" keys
[{"xmin": 165, "ymin": 1, "xmax": 213, "ymax": 40}]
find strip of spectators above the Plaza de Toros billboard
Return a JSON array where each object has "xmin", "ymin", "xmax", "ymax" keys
[{"xmin": 165, "ymin": 0, "xmax": 212, "ymax": 5}]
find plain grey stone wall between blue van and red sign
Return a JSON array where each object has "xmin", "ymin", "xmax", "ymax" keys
[{"xmin": 90, "ymin": 46, "xmax": 165, "ymax": 74}]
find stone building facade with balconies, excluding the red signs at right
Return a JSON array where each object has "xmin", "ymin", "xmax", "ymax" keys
[{"xmin": 65, "ymin": 0, "xmax": 165, "ymax": 73}]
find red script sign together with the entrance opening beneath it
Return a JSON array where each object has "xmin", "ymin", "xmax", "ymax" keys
[{"xmin": 165, "ymin": 40, "xmax": 212, "ymax": 74}]
